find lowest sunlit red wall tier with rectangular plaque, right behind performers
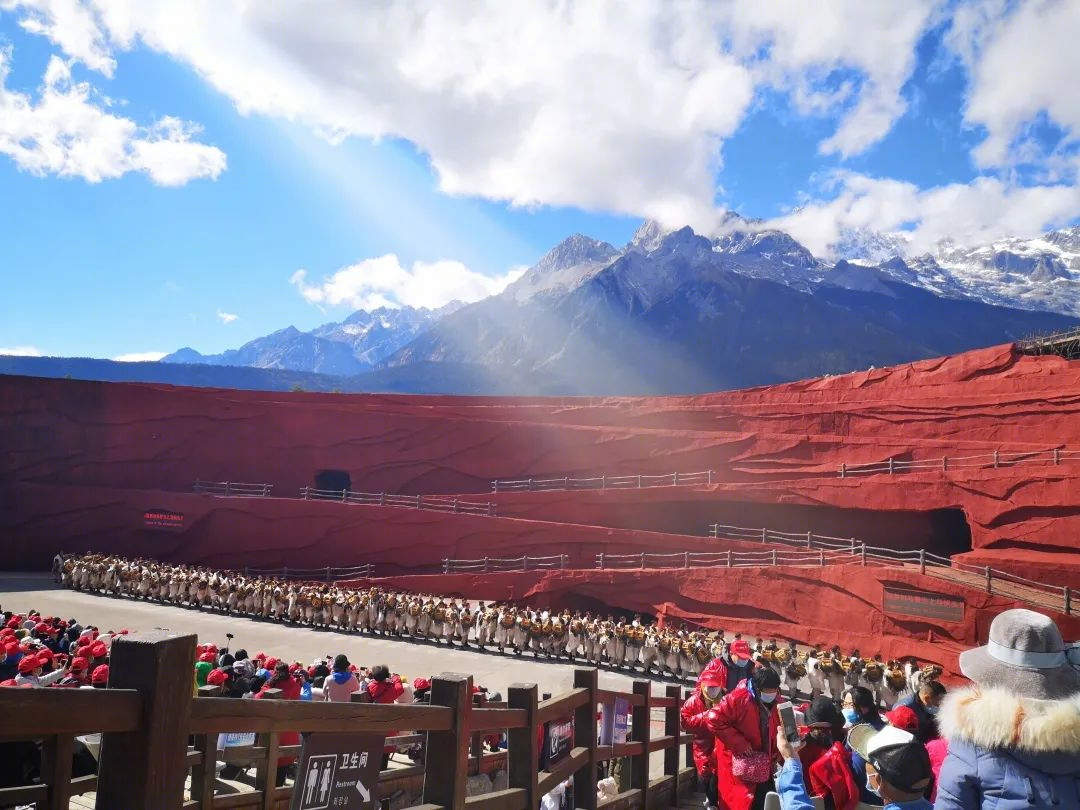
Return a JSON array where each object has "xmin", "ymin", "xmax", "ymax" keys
[{"xmin": 347, "ymin": 565, "xmax": 1080, "ymax": 674}]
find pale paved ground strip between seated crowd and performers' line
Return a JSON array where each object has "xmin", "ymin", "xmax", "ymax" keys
[{"xmin": 0, "ymin": 572, "xmax": 689, "ymax": 699}]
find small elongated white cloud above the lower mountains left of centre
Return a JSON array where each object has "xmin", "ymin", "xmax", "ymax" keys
[{"xmin": 288, "ymin": 254, "xmax": 525, "ymax": 310}]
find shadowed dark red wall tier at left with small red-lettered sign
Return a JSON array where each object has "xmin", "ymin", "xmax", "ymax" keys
[{"xmin": 0, "ymin": 484, "xmax": 760, "ymax": 573}]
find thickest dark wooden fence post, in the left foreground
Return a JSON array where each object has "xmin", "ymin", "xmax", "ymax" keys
[{"xmin": 96, "ymin": 631, "xmax": 197, "ymax": 810}]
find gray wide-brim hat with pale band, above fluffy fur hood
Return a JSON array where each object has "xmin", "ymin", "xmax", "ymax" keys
[{"xmin": 960, "ymin": 609, "xmax": 1080, "ymax": 700}]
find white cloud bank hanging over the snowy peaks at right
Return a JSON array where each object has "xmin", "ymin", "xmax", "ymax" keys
[{"xmin": 769, "ymin": 173, "xmax": 1080, "ymax": 256}]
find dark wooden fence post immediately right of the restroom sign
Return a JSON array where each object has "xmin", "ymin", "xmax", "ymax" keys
[{"xmin": 423, "ymin": 673, "xmax": 472, "ymax": 810}]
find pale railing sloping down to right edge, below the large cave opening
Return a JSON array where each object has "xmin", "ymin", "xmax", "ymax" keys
[{"xmin": 699, "ymin": 523, "xmax": 1074, "ymax": 616}]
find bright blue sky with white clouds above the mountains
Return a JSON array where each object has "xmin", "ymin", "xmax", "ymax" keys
[{"xmin": 0, "ymin": 0, "xmax": 1080, "ymax": 357}]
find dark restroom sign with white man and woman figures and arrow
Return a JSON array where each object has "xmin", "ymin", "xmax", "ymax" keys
[{"xmin": 289, "ymin": 733, "xmax": 384, "ymax": 810}]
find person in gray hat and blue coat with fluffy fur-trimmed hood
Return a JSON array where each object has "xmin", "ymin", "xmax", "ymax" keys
[{"xmin": 934, "ymin": 610, "xmax": 1080, "ymax": 810}]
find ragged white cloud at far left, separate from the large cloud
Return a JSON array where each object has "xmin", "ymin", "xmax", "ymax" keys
[{"xmin": 0, "ymin": 48, "xmax": 226, "ymax": 186}]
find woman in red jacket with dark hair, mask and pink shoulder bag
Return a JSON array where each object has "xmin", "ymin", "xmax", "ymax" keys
[{"xmin": 686, "ymin": 666, "xmax": 780, "ymax": 810}]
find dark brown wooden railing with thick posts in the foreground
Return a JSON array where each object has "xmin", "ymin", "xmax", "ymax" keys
[{"xmin": 0, "ymin": 632, "xmax": 694, "ymax": 810}]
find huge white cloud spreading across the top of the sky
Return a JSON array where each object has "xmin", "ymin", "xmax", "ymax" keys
[{"xmin": 0, "ymin": 0, "xmax": 935, "ymax": 227}]
